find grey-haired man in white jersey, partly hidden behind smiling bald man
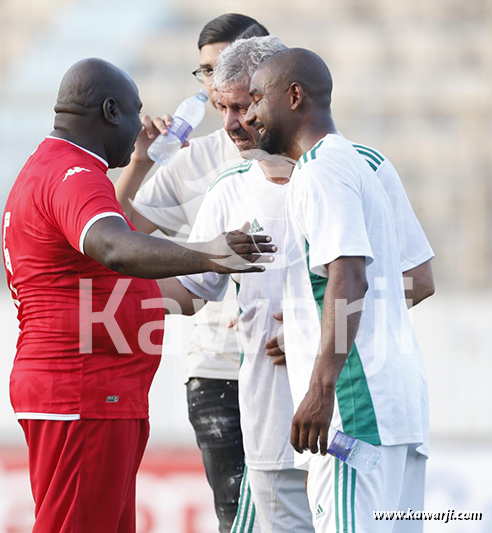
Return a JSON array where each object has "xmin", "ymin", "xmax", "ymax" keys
[{"xmin": 180, "ymin": 37, "xmax": 432, "ymax": 531}]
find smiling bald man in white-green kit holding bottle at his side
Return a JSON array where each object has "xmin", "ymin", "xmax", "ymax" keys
[{"xmin": 246, "ymin": 49, "xmax": 433, "ymax": 533}]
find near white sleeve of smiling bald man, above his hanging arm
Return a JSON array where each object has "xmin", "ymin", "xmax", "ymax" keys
[{"xmin": 290, "ymin": 160, "xmax": 373, "ymax": 276}]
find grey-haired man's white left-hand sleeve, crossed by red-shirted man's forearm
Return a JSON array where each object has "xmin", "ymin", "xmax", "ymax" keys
[{"xmin": 178, "ymin": 189, "xmax": 229, "ymax": 302}]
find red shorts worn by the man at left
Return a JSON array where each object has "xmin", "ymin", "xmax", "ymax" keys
[{"xmin": 20, "ymin": 420, "xmax": 149, "ymax": 533}]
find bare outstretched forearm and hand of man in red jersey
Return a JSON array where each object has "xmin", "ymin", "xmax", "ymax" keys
[{"xmin": 84, "ymin": 216, "xmax": 276, "ymax": 279}]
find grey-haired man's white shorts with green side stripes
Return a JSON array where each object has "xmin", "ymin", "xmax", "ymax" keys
[{"xmin": 231, "ymin": 468, "xmax": 314, "ymax": 533}]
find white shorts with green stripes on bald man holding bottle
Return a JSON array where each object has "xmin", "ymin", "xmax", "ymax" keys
[{"xmin": 307, "ymin": 444, "xmax": 427, "ymax": 533}]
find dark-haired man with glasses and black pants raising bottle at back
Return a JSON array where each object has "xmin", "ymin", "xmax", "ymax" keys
[{"xmin": 116, "ymin": 14, "xmax": 268, "ymax": 532}]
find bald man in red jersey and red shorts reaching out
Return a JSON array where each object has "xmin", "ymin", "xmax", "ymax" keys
[{"xmin": 3, "ymin": 59, "xmax": 276, "ymax": 533}]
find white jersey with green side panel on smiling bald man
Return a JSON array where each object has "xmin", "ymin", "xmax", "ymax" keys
[{"xmin": 283, "ymin": 134, "xmax": 433, "ymax": 465}]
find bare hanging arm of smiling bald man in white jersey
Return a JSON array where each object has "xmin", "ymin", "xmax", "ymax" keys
[{"xmin": 290, "ymin": 257, "xmax": 368, "ymax": 455}]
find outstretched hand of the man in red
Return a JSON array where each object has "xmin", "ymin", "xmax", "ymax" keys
[{"xmin": 204, "ymin": 222, "xmax": 277, "ymax": 274}]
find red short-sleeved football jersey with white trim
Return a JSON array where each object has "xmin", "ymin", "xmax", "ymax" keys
[{"xmin": 2, "ymin": 137, "xmax": 164, "ymax": 420}]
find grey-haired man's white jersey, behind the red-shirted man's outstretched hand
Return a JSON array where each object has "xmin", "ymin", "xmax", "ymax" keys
[{"xmin": 180, "ymin": 161, "xmax": 294, "ymax": 470}]
